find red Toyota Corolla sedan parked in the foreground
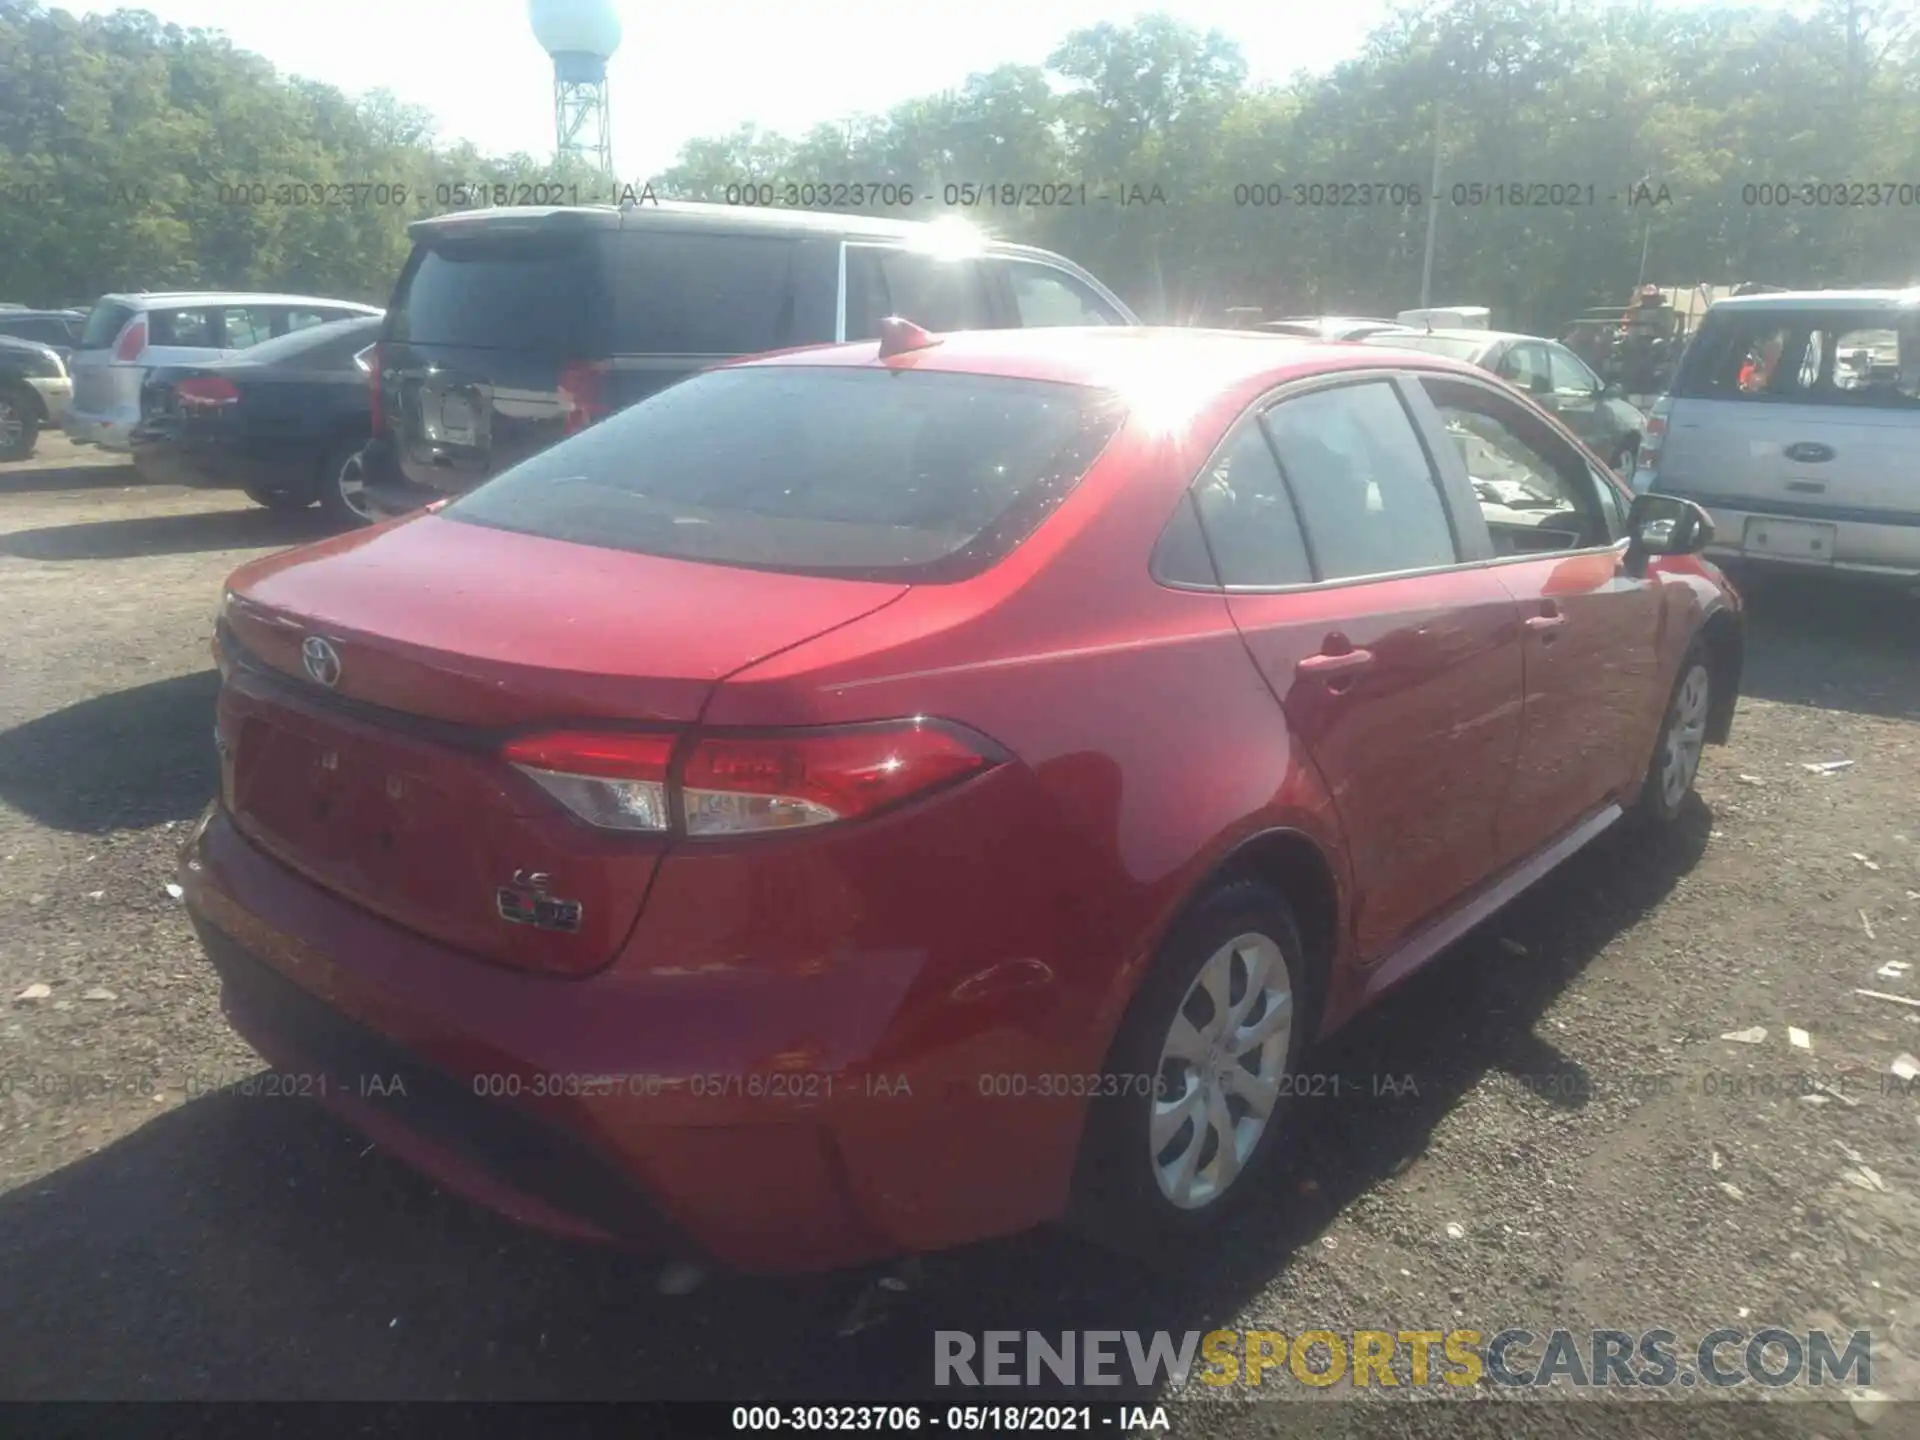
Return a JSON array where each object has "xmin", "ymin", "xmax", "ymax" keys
[{"xmin": 182, "ymin": 323, "xmax": 1743, "ymax": 1271}]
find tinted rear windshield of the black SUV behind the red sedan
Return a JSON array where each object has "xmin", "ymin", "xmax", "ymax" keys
[{"xmin": 390, "ymin": 234, "xmax": 601, "ymax": 357}]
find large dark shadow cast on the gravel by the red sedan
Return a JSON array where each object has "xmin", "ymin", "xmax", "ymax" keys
[{"xmin": 0, "ymin": 802, "xmax": 1713, "ymax": 1402}]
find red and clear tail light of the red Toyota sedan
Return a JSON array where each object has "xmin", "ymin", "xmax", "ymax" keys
[{"xmin": 505, "ymin": 720, "xmax": 1004, "ymax": 835}]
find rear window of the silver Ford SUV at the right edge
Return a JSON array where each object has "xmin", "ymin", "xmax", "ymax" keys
[{"xmin": 1674, "ymin": 305, "xmax": 1920, "ymax": 409}]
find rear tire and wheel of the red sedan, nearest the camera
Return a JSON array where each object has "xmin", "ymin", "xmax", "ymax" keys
[{"xmin": 1069, "ymin": 881, "xmax": 1317, "ymax": 1261}]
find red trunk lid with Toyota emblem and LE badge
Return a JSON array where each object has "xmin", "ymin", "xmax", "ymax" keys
[{"xmin": 219, "ymin": 515, "xmax": 906, "ymax": 973}]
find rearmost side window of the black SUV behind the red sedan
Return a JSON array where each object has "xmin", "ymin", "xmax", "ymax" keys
[{"xmin": 614, "ymin": 230, "xmax": 795, "ymax": 355}]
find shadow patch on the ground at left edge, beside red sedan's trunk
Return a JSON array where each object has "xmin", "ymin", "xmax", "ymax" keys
[{"xmin": 0, "ymin": 670, "xmax": 221, "ymax": 835}]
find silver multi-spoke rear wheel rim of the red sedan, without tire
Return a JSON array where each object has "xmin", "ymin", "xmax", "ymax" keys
[{"xmin": 1148, "ymin": 933, "xmax": 1294, "ymax": 1210}]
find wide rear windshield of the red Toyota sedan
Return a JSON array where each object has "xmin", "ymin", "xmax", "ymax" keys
[{"xmin": 444, "ymin": 365, "xmax": 1121, "ymax": 584}]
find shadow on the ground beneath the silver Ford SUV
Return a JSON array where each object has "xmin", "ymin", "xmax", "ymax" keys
[{"xmin": 1736, "ymin": 574, "xmax": 1920, "ymax": 720}]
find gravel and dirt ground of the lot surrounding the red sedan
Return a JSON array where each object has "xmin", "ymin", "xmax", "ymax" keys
[{"xmin": 0, "ymin": 438, "xmax": 1920, "ymax": 1436}]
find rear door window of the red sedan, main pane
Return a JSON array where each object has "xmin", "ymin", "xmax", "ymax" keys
[{"xmin": 1265, "ymin": 380, "xmax": 1459, "ymax": 580}]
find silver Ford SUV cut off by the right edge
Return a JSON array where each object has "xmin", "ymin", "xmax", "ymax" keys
[{"xmin": 1634, "ymin": 290, "xmax": 1920, "ymax": 584}]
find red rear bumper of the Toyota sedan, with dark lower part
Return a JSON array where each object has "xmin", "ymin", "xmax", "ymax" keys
[{"xmin": 180, "ymin": 806, "xmax": 1083, "ymax": 1273}]
